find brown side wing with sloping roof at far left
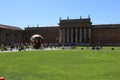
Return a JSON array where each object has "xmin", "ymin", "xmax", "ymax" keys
[{"xmin": 0, "ymin": 24, "xmax": 25, "ymax": 44}]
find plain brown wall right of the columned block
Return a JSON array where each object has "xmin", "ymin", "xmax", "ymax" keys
[{"xmin": 91, "ymin": 24, "xmax": 120, "ymax": 45}]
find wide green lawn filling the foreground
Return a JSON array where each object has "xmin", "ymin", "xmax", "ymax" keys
[{"xmin": 0, "ymin": 48, "xmax": 120, "ymax": 80}]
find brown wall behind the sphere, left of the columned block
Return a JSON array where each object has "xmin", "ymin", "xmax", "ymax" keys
[{"xmin": 25, "ymin": 26, "xmax": 59, "ymax": 43}]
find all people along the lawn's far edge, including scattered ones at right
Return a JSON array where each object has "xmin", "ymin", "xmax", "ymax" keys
[{"xmin": 0, "ymin": 42, "xmax": 114, "ymax": 51}]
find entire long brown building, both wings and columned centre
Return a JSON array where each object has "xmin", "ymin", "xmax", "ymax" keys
[{"xmin": 0, "ymin": 17, "xmax": 120, "ymax": 45}]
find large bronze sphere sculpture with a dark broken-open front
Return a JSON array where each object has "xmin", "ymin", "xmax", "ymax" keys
[{"xmin": 30, "ymin": 34, "xmax": 43, "ymax": 49}]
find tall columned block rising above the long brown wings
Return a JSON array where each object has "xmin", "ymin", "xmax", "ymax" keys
[{"xmin": 59, "ymin": 18, "xmax": 92, "ymax": 44}]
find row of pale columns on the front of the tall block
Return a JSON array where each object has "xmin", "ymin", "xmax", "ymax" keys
[{"xmin": 59, "ymin": 27, "xmax": 91, "ymax": 43}]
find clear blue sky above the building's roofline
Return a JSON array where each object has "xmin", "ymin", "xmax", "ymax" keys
[{"xmin": 0, "ymin": 0, "xmax": 120, "ymax": 28}]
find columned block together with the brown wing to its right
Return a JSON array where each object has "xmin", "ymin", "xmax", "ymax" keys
[{"xmin": 59, "ymin": 17, "xmax": 120, "ymax": 45}]
